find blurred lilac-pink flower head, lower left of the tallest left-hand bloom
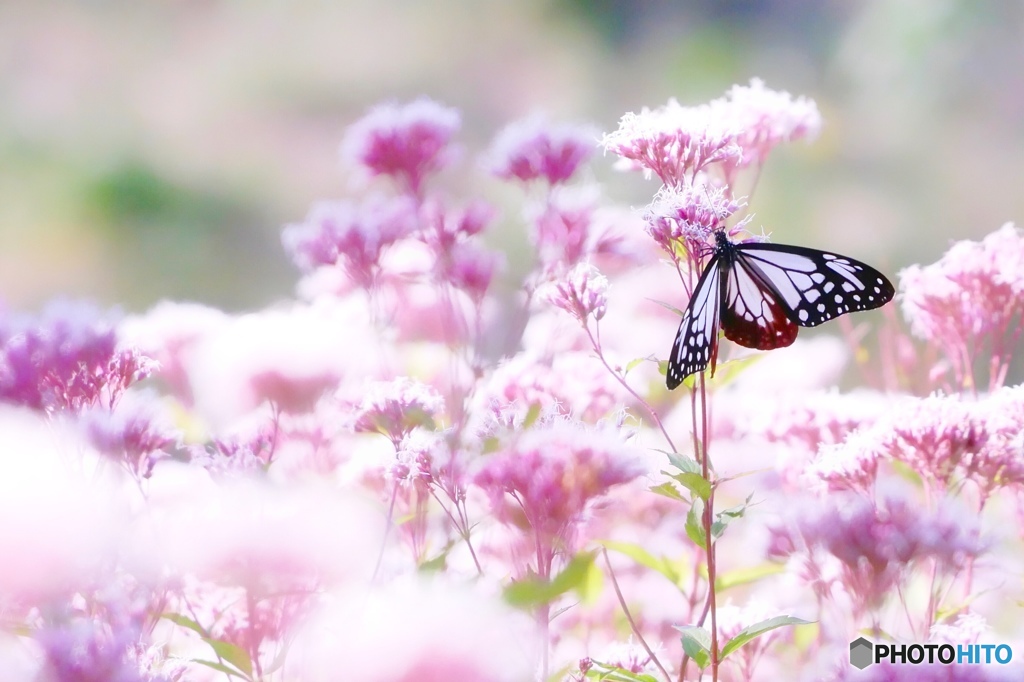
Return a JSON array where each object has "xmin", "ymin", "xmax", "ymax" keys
[{"xmin": 282, "ymin": 197, "xmax": 418, "ymax": 288}]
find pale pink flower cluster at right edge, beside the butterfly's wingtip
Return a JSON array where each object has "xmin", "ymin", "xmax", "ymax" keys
[{"xmin": 900, "ymin": 223, "xmax": 1024, "ymax": 388}]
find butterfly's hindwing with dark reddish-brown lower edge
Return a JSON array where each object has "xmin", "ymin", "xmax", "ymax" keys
[{"xmin": 721, "ymin": 251, "xmax": 797, "ymax": 350}]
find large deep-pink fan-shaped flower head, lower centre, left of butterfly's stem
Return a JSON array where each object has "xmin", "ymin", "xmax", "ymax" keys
[{"xmin": 473, "ymin": 421, "xmax": 643, "ymax": 576}]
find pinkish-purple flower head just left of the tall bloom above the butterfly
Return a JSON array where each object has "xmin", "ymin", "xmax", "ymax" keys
[{"xmin": 487, "ymin": 116, "xmax": 597, "ymax": 184}]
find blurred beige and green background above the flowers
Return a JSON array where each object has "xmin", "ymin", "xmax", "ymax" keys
[{"xmin": 0, "ymin": 0, "xmax": 1024, "ymax": 311}]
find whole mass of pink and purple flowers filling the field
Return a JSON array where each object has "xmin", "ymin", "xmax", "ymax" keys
[{"xmin": 0, "ymin": 90, "xmax": 1024, "ymax": 682}]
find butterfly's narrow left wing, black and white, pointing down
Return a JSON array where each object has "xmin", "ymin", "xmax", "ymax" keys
[{"xmin": 665, "ymin": 255, "xmax": 722, "ymax": 390}]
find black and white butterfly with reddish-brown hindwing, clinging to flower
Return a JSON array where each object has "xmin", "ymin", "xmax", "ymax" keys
[{"xmin": 665, "ymin": 228, "xmax": 896, "ymax": 389}]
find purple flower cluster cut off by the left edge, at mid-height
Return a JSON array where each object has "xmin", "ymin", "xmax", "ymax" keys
[{"xmin": 0, "ymin": 301, "xmax": 154, "ymax": 413}]
